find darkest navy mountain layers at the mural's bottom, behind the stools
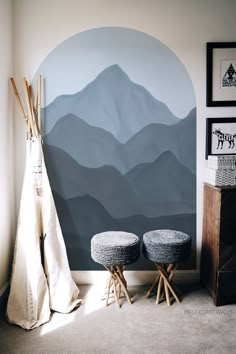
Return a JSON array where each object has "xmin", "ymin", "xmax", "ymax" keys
[{"xmin": 53, "ymin": 191, "xmax": 196, "ymax": 270}]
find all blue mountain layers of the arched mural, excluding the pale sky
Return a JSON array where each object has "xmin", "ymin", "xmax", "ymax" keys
[{"xmin": 43, "ymin": 65, "xmax": 196, "ymax": 270}]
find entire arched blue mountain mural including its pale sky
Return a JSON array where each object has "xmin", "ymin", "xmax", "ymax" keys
[{"xmin": 36, "ymin": 27, "xmax": 196, "ymax": 270}]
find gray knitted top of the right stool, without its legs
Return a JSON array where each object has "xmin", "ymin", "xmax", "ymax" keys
[{"xmin": 143, "ymin": 230, "xmax": 191, "ymax": 263}]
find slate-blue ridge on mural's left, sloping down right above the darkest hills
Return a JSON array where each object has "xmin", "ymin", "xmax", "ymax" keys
[{"xmin": 44, "ymin": 144, "xmax": 142, "ymax": 217}]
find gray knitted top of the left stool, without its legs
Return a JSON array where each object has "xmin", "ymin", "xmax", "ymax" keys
[{"xmin": 91, "ymin": 231, "xmax": 140, "ymax": 266}]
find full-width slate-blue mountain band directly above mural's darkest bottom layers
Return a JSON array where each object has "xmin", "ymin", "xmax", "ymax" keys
[{"xmin": 43, "ymin": 144, "xmax": 195, "ymax": 218}]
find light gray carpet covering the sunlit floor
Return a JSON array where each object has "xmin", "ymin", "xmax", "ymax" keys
[{"xmin": 0, "ymin": 285, "xmax": 236, "ymax": 354}]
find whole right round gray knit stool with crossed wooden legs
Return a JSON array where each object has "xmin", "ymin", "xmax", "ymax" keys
[{"xmin": 143, "ymin": 230, "xmax": 191, "ymax": 306}]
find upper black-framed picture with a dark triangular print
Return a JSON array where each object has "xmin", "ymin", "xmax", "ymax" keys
[{"xmin": 206, "ymin": 42, "xmax": 236, "ymax": 107}]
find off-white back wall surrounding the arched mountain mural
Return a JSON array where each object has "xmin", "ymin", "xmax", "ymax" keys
[{"xmin": 13, "ymin": 0, "xmax": 236, "ymax": 282}]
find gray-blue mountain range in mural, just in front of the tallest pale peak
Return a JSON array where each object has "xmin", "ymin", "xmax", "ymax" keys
[{"xmin": 44, "ymin": 109, "xmax": 196, "ymax": 174}]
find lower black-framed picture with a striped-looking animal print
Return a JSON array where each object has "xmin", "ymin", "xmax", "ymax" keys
[{"xmin": 206, "ymin": 118, "xmax": 236, "ymax": 159}]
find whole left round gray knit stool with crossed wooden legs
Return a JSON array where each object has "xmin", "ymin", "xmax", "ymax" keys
[{"xmin": 91, "ymin": 231, "xmax": 140, "ymax": 307}]
